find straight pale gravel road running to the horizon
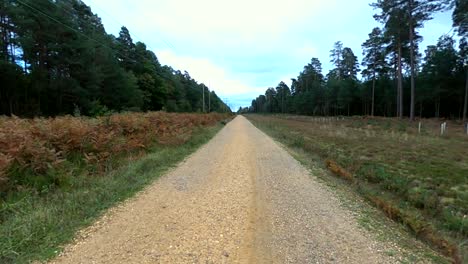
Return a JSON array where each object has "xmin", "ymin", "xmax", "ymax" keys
[{"xmin": 52, "ymin": 116, "xmax": 402, "ymax": 263}]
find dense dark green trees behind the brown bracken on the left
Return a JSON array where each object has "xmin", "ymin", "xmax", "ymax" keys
[{"xmin": 0, "ymin": 0, "xmax": 230, "ymax": 116}]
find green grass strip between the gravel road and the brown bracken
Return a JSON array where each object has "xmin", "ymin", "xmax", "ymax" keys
[{"xmin": 0, "ymin": 125, "xmax": 222, "ymax": 263}]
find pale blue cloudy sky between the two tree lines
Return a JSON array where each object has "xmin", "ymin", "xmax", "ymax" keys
[{"xmin": 83, "ymin": 0, "xmax": 452, "ymax": 110}]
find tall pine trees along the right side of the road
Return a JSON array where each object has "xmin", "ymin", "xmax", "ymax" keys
[{"xmin": 243, "ymin": 0, "xmax": 468, "ymax": 120}]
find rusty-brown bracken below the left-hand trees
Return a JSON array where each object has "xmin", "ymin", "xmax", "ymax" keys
[{"xmin": 0, "ymin": 112, "xmax": 227, "ymax": 193}]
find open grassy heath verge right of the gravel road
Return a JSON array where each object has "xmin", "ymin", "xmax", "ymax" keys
[{"xmin": 247, "ymin": 115, "xmax": 468, "ymax": 263}]
